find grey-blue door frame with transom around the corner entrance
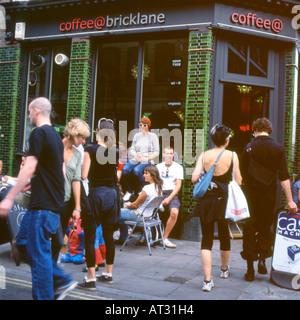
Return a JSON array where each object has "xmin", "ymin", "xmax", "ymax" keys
[{"xmin": 208, "ymin": 32, "xmax": 286, "ymax": 147}]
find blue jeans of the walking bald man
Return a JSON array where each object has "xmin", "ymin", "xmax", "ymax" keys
[{"xmin": 17, "ymin": 210, "xmax": 72, "ymax": 300}]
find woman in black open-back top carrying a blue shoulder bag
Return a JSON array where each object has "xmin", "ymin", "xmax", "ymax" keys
[{"xmin": 192, "ymin": 124, "xmax": 242, "ymax": 291}]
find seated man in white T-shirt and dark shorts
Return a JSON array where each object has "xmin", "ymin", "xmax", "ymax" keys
[{"xmin": 157, "ymin": 147, "xmax": 183, "ymax": 248}]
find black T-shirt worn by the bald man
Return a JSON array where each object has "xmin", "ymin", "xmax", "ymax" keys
[{"xmin": 28, "ymin": 125, "xmax": 64, "ymax": 213}]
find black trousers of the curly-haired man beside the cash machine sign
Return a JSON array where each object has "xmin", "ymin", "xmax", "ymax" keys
[{"xmin": 241, "ymin": 189, "xmax": 276, "ymax": 261}]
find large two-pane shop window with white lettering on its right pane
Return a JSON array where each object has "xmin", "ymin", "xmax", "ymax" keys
[{"xmin": 94, "ymin": 38, "xmax": 188, "ymax": 159}]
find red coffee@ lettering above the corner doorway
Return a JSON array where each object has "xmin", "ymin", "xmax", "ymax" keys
[{"xmin": 231, "ymin": 12, "xmax": 283, "ymax": 33}]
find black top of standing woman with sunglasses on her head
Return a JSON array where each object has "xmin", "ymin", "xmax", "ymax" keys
[{"xmin": 85, "ymin": 144, "xmax": 118, "ymax": 188}]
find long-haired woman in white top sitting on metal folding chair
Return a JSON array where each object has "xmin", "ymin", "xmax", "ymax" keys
[{"xmin": 119, "ymin": 164, "xmax": 163, "ymax": 242}]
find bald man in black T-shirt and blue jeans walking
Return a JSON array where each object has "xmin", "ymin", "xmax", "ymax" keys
[{"xmin": 0, "ymin": 97, "xmax": 77, "ymax": 300}]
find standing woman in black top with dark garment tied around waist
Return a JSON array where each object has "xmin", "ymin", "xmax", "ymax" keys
[{"xmin": 78, "ymin": 119, "xmax": 118, "ymax": 290}]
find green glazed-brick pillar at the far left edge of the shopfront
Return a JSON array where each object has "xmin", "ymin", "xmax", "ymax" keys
[{"xmin": 0, "ymin": 45, "xmax": 23, "ymax": 175}]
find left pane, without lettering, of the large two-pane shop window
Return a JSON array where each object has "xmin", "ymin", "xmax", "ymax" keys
[{"xmin": 94, "ymin": 42, "xmax": 138, "ymax": 139}]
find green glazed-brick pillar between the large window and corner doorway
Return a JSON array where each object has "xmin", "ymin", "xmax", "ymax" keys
[{"xmin": 182, "ymin": 30, "xmax": 214, "ymax": 241}]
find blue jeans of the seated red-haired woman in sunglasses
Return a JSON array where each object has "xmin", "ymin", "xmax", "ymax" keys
[{"xmin": 122, "ymin": 161, "xmax": 151, "ymax": 193}]
